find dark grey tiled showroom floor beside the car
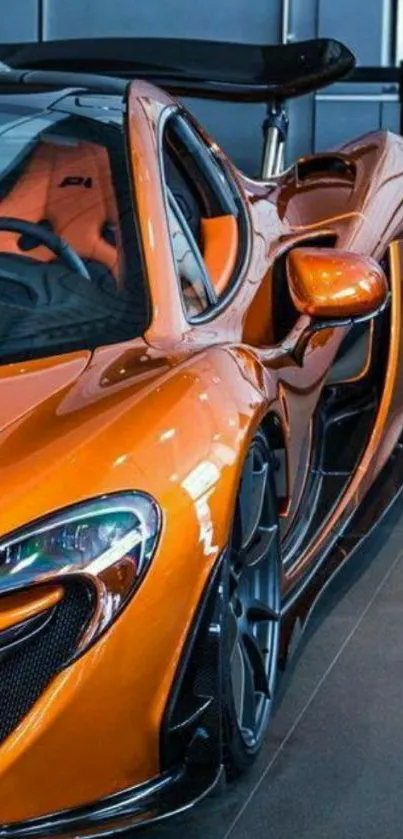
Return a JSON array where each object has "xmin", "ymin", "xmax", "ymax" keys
[{"xmin": 143, "ymin": 492, "xmax": 403, "ymax": 839}]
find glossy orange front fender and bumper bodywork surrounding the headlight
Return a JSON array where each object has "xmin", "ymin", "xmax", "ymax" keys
[{"xmin": 0, "ymin": 345, "xmax": 272, "ymax": 820}]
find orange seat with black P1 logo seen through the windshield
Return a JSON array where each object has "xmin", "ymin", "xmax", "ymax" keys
[{"xmin": 0, "ymin": 141, "xmax": 119, "ymax": 284}]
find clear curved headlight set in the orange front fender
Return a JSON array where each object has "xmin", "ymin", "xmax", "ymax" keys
[{"xmin": 0, "ymin": 492, "xmax": 161, "ymax": 646}]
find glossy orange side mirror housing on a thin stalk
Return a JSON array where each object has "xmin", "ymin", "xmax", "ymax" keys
[{"xmin": 287, "ymin": 248, "xmax": 388, "ymax": 320}]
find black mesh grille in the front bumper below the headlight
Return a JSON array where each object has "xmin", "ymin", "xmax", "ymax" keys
[{"xmin": 0, "ymin": 582, "xmax": 93, "ymax": 743}]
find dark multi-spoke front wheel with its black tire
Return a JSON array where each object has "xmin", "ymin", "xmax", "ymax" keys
[{"xmin": 223, "ymin": 431, "xmax": 281, "ymax": 778}]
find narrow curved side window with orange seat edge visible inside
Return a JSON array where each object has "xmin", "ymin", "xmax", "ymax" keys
[{"xmin": 163, "ymin": 114, "xmax": 245, "ymax": 317}]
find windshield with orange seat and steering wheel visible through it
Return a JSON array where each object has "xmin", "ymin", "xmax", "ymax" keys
[{"xmin": 0, "ymin": 91, "xmax": 148, "ymax": 363}]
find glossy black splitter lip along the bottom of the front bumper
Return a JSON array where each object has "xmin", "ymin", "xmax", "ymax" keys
[{"xmin": 0, "ymin": 767, "xmax": 222, "ymax": 839}]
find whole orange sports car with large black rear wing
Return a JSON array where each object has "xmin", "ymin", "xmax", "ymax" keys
[{"xmin": 0, "ymin": 32, "xmax": 403, "ymax": 839}]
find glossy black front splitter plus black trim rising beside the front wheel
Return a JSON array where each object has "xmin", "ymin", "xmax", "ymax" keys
[{"xmin": 0, "ymin": 553, "xmax": 225, "ymax": 839}]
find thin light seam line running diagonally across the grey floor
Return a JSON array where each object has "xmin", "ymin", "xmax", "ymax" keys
[{"xmin": 221, "ymin": 549, "xmax": 403, "ymax": 839}]
